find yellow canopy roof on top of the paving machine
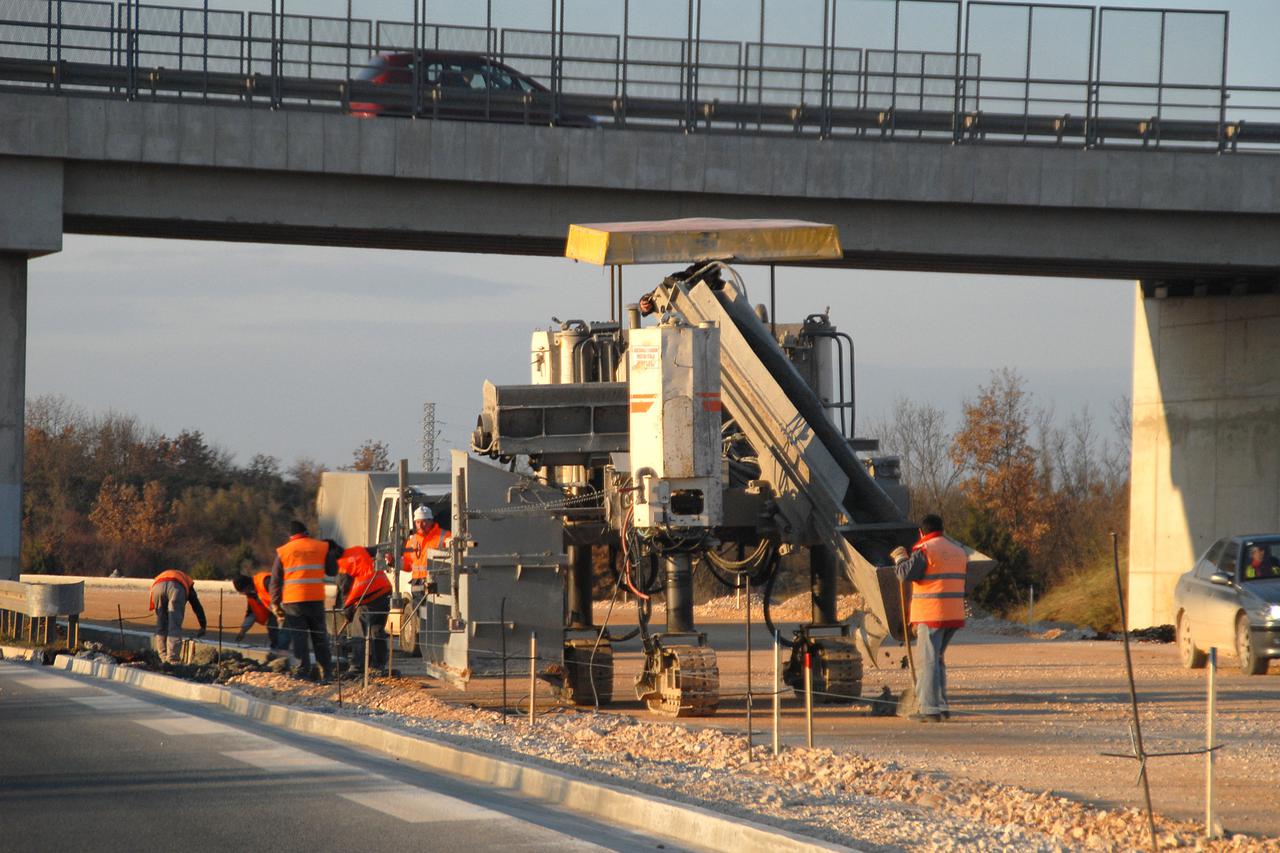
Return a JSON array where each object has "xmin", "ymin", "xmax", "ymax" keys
[{"xmin": 564, "ymin": 219, "xmax": 844, "ymax": 266}]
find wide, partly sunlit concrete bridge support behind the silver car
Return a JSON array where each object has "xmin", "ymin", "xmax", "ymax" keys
[{"xmin": 1128, "ymin": 283, "xmax": 1280, "ymax": 628}]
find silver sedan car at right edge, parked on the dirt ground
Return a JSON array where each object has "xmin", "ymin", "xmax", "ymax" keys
[{"xmin": 1174, "ymin": 534, "xmax": 1280, "ymax": 675}]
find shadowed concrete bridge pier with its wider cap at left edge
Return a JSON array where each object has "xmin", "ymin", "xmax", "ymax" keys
[{"xmin": 0, "ymin": 156, "xmax": 63, "ymax": 580}]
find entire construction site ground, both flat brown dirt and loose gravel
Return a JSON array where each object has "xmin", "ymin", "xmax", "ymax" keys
[{"xmin": 70, "ymin": 588, "xmax": 1280, "ymax": 850}]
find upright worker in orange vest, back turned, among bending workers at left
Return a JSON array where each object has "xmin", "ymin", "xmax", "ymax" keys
[{"xmin": 270, "ymin": 521, "xmax": 338, "ymax": 681}]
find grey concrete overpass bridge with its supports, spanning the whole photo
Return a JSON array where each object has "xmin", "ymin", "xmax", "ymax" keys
[{"xmin": 0, "ymin": 0, "xmax": 1280, "ymax": 624}]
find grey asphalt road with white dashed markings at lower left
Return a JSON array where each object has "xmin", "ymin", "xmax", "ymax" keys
[{"xmin": 0, "ymin": 662, "xmax": 678, "ymax": 853}]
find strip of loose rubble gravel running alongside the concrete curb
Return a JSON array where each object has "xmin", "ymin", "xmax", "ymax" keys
[{"xmin": 229, "ymin": 671, "xmax": 1280, "ymax": 850}]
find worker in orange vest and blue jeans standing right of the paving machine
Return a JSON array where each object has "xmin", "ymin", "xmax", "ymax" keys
[{"xmin": 892, "ymin": 515, "xmax": 969, "ymax": 722}]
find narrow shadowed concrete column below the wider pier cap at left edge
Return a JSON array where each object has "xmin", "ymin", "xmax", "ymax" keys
[{"xmin": 0, "ymin": 252, "xmax": 27, "ymax": 580}]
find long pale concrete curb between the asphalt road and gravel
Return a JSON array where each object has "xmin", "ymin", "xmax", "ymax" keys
[{"xmin": 54, "ymin": 654, "xmax": 856, "ymax": 853}]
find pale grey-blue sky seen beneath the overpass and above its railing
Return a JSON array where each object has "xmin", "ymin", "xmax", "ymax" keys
[{"xmin": 27, "ymin": 0, "xmax": 1280, "ymax": 467}]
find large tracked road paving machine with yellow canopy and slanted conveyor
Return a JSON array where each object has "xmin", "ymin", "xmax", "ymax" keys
[{"xmin": 421, "ymin": 219, "xmax": 988, "ymax": 716}]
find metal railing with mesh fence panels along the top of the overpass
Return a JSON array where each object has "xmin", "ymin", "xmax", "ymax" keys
[{"xmin": 0, "ymin": 0, "xmax": 1280, "ymax": 151}]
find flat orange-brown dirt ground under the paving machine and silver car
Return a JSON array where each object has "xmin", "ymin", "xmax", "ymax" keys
[{"xmin": 72, "ymin": 581, "xmax": 1280, "ymax": 850}]
